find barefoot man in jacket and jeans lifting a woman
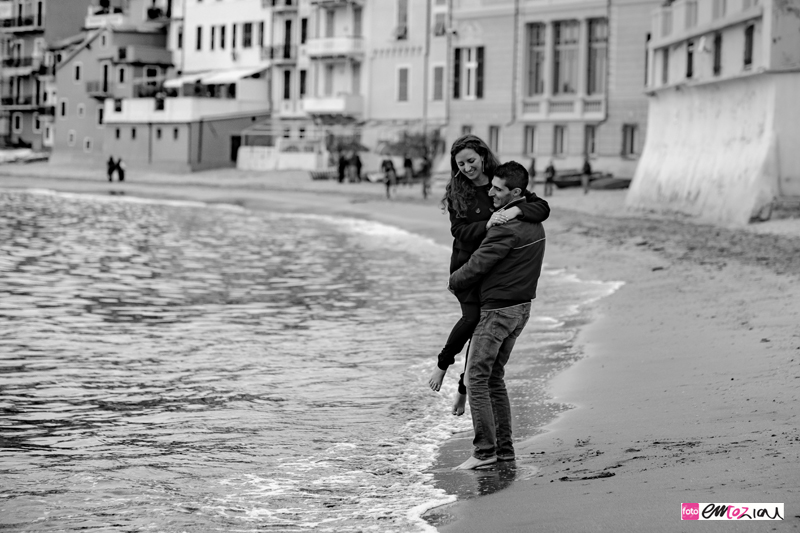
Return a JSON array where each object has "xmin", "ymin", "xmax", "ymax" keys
[{"xmin": 448, "ymin": 161, "xmax": 545, "ymax": 470}]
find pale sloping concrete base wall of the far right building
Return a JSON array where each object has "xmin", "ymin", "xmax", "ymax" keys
[{"xmin": 626, "ymin": 75, "xmax": 780, "ymax": 224}]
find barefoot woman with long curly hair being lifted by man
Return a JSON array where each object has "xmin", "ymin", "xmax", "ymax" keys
[{"xmin": 428, "ymin": 135, "xmax": 550, "ymax": 416}]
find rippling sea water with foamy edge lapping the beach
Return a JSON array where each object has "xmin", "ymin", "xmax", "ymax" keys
[{"xmin": 0, "ymin": 191, "xmax": 615, "ymax": 532}]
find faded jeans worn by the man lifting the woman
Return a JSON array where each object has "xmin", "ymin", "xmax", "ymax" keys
[{"xmin": 467, "ymin": 303, "xmax": 531, "ymax": 459}]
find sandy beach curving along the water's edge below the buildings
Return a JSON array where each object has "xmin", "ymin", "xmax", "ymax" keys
[{"xmin": 0, "ymin": 164, "xmax": 800, "ymax": 532}]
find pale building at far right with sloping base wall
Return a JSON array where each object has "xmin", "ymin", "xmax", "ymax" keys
[{"xmin": 627, "ymin": 0, "xmax": 800, "ymax": 224}]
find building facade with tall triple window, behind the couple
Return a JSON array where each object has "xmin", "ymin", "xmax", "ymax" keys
[{"xmin": 447, "ymin": 0, "xmax": 657, "ymax": 176}]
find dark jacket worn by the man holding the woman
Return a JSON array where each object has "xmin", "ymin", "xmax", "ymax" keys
[{"xmin": 450, "ymin": 200, "xmax": 545, "ymax": 309}]
